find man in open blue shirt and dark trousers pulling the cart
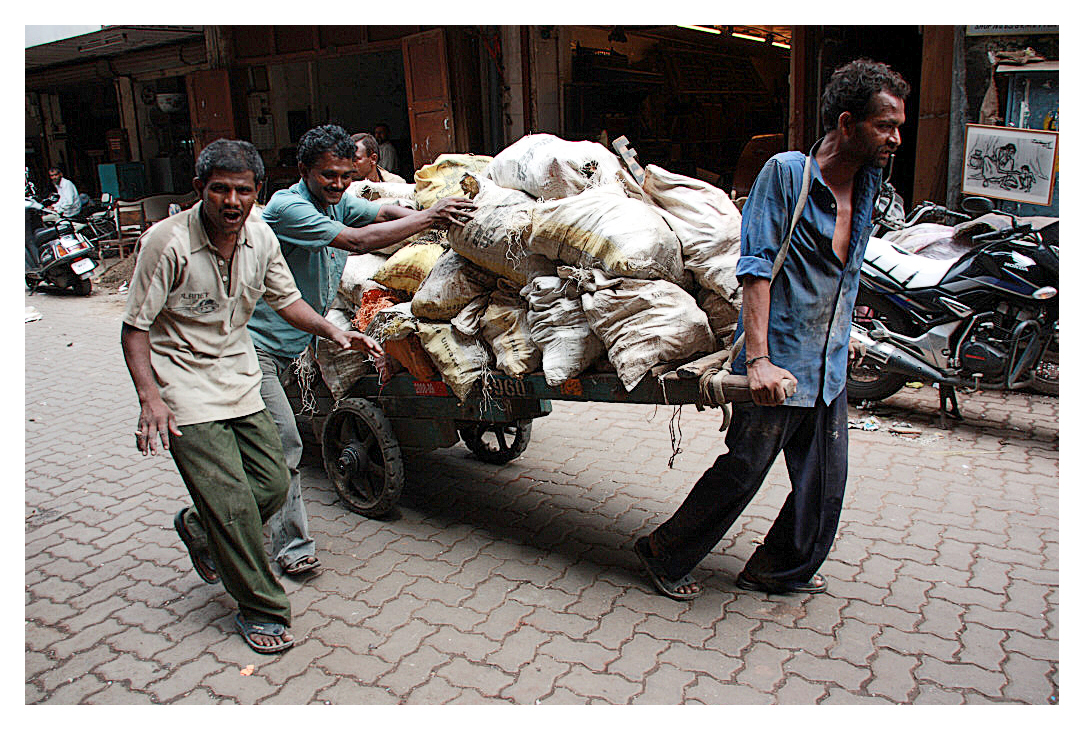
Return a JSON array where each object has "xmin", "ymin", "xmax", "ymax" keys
[{"xmin": 635, "ymin": 60, "xmax": 909, "ymax": 601}]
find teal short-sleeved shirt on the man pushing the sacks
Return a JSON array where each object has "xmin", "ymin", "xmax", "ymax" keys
[{"xmin": 248, "ymin": 180, "xmax": 380, "ymax": 358}]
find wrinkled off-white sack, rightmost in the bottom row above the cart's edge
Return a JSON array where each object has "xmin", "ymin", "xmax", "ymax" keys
[{"xmin": 580, "ymin": 269, "xmax": 717, "ymax": 390}]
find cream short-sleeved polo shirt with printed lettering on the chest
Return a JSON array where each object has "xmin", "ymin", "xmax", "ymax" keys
[{"xmin": 124, "ymin": 202, "xmax": 301, "ymax": 426}]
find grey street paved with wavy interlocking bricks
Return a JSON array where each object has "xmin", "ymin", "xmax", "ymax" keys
[{"xmin": 25, "ymin": 293, "xmax": 1059, "ymax": 704}]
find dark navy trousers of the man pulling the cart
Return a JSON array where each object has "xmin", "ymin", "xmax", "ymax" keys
[{"xmin": 655, "ymin": 390, "xmax": 848, "ymax": 581}]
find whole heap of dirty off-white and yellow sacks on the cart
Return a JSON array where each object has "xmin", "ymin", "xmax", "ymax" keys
[{"xmin": 315, "ymin": 135, "xmax": 741, "ymax": 400}]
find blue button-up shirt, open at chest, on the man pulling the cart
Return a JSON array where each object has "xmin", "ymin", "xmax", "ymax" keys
[{"xmin": 733, "ymin": 146, "xmax": 880, "ymax": 407}]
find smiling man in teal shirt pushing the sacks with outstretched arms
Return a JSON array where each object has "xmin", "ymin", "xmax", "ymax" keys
[{"xmin": 248, "ymin": 125, "xmax": 474, "ymax": 575}]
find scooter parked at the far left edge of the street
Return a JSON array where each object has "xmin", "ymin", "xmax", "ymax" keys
[{"xmin": 25, "ymin": 197, "xmax": 98, "ymax": 296}]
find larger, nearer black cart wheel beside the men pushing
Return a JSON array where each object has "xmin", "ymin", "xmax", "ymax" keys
[{"xmin": 321, "ymin": 398, "xmax": 404, "ymax": 517}]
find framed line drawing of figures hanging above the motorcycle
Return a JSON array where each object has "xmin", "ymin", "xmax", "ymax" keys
[{"xmin": 964, "ymin": 125, "xmax": 1058, "ymax": 205}]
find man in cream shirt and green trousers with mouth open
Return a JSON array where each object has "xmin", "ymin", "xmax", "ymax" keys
[{"xmin": 120, "ymin": 140, "xmax": 380, "ymax": 653}]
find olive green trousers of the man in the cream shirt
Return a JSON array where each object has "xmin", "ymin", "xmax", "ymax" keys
[{"xmin": 169, "ymin": 409, "xmax": 291, "ymax": 626}]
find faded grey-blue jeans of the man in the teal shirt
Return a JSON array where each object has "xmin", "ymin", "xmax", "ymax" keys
[{"xmin": 256, "ymin": 347, "xmax": 317, "ymax": 567}]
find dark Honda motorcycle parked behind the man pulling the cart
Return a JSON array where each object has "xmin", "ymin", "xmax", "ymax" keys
[{"xmin": 847, "ymin": 197, "xmax": 1060, "ymax": 420}]
